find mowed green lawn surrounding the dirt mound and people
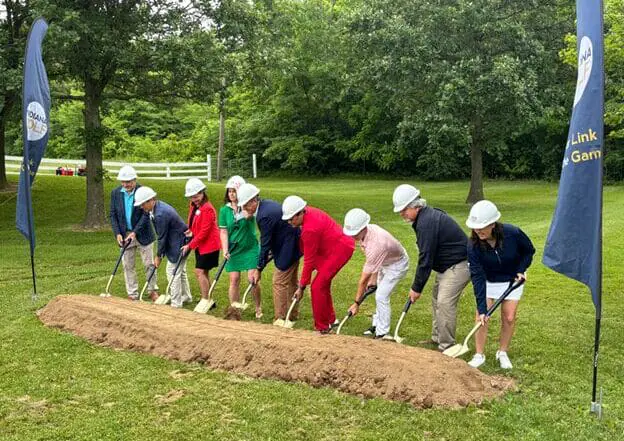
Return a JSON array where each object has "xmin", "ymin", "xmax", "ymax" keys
[{"xmin": 0, "ymin": 177, "xmax": 624, "ymax": 441}]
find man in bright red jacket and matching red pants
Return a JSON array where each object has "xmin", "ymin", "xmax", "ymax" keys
[{"xmin": 282, "ymin": 196, "xmax": 355, "ymax": 334}]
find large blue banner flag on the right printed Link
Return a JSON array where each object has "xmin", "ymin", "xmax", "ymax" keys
[{"xmin": 542, "ymin": 0, "xmax": 604, "ymax": 312}]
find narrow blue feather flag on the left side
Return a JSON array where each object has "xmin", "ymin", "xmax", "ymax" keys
[{"xmin": 15, "ymin": 18, "xmax": 50, "ymax": 256}]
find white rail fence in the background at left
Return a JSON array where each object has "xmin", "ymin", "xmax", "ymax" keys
[{"xmin": 4, "ymin": 154, "xmax": 258, "ymax": 181}]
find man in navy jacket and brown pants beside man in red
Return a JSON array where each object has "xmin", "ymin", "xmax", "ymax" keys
[{"xmin": 238, "ymin": 183, "xmax": 301, "ymax": 321}]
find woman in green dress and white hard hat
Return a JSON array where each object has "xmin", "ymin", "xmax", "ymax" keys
[{"xmin": 219, "ymin": 176, "xmax": 262, "ymax": 319}]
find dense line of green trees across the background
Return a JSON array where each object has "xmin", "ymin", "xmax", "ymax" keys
[{"xmin": 0, "ymin": 0, "xmax": 624, "ymax": 226}]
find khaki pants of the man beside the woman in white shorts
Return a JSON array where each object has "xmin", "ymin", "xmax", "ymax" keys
[{"xmin": 431, "ymin": 260, "xmax": 470, "ymax": 350}]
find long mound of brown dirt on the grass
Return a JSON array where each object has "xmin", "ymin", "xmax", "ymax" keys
[{"xmin": 39, "ymin": 295, "xmax": 513, "ymax": 408}]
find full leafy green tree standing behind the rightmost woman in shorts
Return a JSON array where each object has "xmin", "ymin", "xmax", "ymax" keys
[{"xmin": 353, "ymin": 0, "xmax": 564, "ymax": 202}]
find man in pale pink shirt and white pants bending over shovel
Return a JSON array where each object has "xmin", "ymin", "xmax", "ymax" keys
[{"xmin": 343, "ymin": 208, "xmax": 409, "ymax": 338}]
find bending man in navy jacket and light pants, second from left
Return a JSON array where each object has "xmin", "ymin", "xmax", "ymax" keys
[{"xmin": 134, "ymin": 187, "xmax": 192, "ymax": 308}]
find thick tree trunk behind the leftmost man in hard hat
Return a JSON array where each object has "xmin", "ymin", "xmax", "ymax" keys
[{"xmin": 83, "ymin": 76, "xmax": 106, "ymax": 228}]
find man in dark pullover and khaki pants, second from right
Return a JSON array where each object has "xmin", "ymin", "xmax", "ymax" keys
[{"xmin": 392, "ymin": 184, "xmax": 470, "ymax": 351}]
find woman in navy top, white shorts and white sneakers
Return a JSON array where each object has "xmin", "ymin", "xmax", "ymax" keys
[{"xmin": 466, "ymin": 200, "xmax": 535, "ymax": 369}]
